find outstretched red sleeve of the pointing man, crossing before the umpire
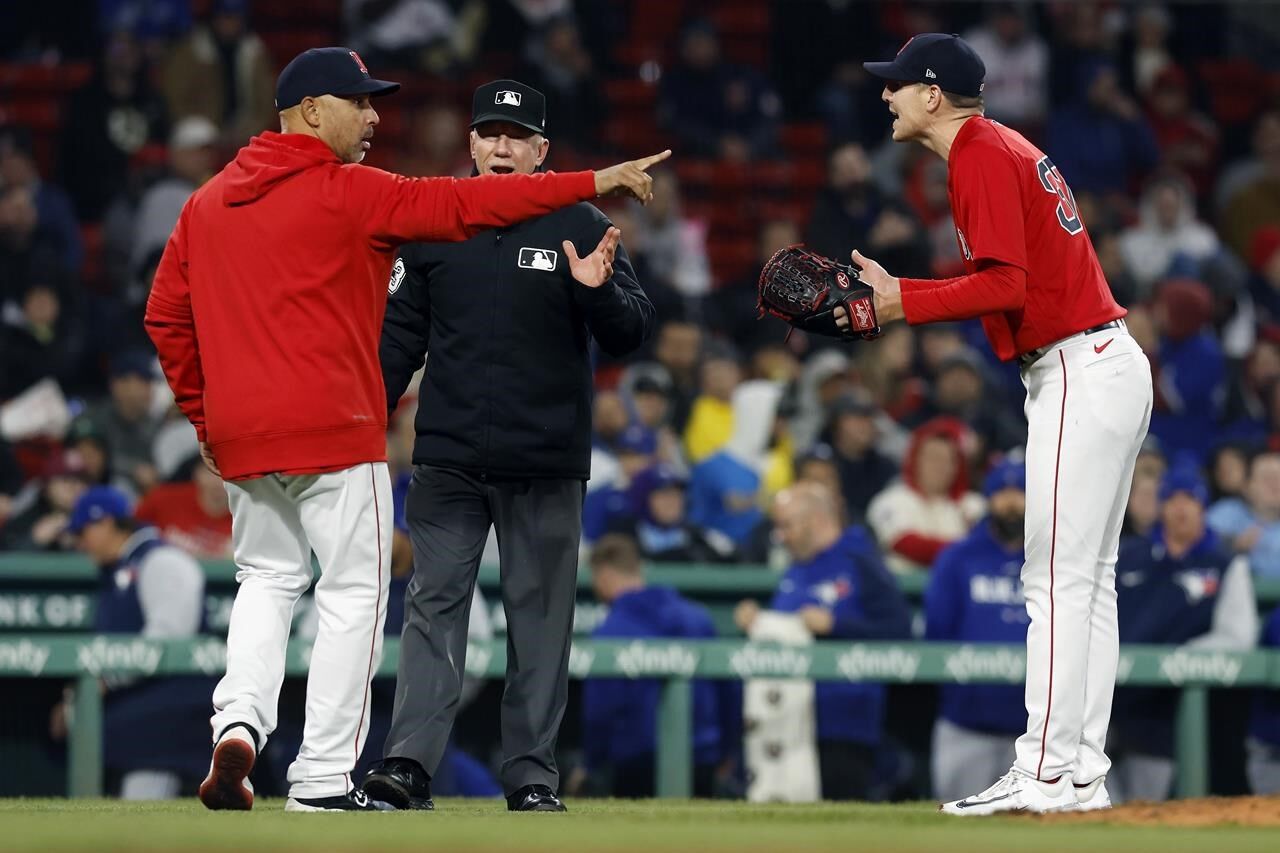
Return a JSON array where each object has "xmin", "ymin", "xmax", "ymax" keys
[{"xmin": 344, "ymin": 167, "xmax": 595, "ymax": 245}]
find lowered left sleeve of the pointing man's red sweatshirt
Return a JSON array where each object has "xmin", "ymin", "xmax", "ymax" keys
[{"xmin": 143, "ymin": 203, "xmax": 209, "ymax": 442}]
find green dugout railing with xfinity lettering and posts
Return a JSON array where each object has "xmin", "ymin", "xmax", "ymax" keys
[{"xmin": 0, "ymin": 633, "xmax": 1280, "ymax": 797}]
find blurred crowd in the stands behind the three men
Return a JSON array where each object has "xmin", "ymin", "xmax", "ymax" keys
[{"xmin": 0, "ymin": 0, "xmax": 1280, "ymax": 793}]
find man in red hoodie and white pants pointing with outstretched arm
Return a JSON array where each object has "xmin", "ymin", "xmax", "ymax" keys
[{"xmin": 146, "ymin": 47, "xmax": 669, "ymax": 811}]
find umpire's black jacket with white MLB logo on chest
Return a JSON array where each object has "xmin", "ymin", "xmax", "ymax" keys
[{"xmin": 379, "ymin": 204, "xmax": 654, "ymax": 480}]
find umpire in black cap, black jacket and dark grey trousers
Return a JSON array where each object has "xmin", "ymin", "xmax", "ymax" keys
[{"xmin": 364, "ymin": 79, "xmax": 654, "ymax": 811}]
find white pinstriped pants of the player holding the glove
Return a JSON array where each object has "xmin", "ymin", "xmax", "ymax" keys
[{"xmin": 1015, "ymin": 328, "xmax": 1152, "ymax": 784}]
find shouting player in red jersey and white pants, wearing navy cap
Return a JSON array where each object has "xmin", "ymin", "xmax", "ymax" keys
[{"xmin": 854, "ymin": 33, "xmax": 1152, "ymax": 815}]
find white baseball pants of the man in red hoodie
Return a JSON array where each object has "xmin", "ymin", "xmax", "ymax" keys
[{"xmin": 211, "ymin": 462, "xmax": 393, "ymax": 797}]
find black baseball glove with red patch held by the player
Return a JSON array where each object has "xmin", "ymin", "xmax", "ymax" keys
[{"xmin": 755, "ymin": 246, "xmax": 881, "ymax": 341}]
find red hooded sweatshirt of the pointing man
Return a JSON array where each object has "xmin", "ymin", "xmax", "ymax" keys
[{"xmin": 146, "ymin": 132, "xmax": 595, "ymax": 480}]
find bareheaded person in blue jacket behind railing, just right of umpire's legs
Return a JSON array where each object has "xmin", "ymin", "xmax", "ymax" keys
[{"xmin": 581, "ymin": 533, "xmax": 740, "ymax": 798}]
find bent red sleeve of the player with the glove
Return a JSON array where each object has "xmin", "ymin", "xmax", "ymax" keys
[{"xmin": 901, "ymin": 145, "xmax": 1028, "ymax": 324}]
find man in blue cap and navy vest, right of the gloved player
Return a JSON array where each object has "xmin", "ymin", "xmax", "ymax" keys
[{"xmin": 1107, "ymin": 466, "xmax": 1258, "ymax": 802}]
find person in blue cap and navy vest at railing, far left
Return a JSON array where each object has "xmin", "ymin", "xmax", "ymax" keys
[{"xmin": 55, "ymin": 485, "xmax": 214, "ymax": 799}]
